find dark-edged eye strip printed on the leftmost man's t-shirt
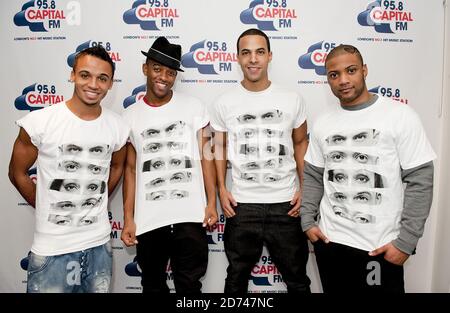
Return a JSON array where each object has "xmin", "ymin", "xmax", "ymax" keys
[{"xmin": 50, "ymin": 179, "xmax": 106, "ymax": 195}]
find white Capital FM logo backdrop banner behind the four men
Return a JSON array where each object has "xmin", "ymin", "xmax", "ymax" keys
[{"xmin": 0, "ymin": 0, "xmax": 444, "ymax": 292}]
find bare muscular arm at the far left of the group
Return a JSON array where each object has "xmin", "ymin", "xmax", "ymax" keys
[{"xmin": 8, "ymin": 127, "xmax": 38, "ymax": 208}]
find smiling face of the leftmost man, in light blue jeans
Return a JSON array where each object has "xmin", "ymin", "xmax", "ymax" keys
[{"xmin": 70, "ymin": 55, "xmax": 113, "ymax": 107}]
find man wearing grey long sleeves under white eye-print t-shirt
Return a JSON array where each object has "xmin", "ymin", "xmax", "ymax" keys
[{"xmin": 301, "ymin": 45, "xmax": 436, "ymax": 293}]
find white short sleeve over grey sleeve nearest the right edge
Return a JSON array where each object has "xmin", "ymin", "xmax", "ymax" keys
[{"xmin": 396, "ymin": 105, "xmax": 436, "ymax": 170}]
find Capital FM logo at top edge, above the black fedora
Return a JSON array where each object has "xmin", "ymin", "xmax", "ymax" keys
[{"xmin": 123, "ymin": 0, "xmax": 180, "ymax": 30}]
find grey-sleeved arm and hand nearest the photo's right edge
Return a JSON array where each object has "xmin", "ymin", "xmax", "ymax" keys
[{"xmin": 370, "ymin": 161, "xmax": 434, "ymax": 265}]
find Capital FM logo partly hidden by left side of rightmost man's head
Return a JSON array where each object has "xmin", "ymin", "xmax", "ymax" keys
[{"xmin": 298, "ymin": 41, "xmax": 336, "ymax": 76}]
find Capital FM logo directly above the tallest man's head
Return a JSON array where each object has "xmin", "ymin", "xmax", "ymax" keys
[{"xmin": 240, "ymin": 0, "xmax": 298, "ymax": 31}]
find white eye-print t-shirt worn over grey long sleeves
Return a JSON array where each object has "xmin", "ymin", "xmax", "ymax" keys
[{"xmin": 305, "ymin": 97, "xmax": 436, "ymax": 251}]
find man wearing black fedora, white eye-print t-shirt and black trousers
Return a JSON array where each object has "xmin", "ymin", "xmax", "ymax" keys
[{"xmin": 121, "ymin": 37, "xmax": 217, "ymax": 293}]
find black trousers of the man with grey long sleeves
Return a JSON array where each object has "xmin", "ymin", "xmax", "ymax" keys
[{"xmin": 313, "ymin": 240, "xmax": 405, "ymax": 294}]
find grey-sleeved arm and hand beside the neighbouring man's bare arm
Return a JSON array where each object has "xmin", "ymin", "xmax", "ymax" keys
[{"xmin": 300, "ymin": 161, "xmax": 328, "ymax": 243}]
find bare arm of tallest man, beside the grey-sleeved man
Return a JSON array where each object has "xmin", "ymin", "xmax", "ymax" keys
[{"xmin": 288, "ymin": 121, "xmax": 308, "ymax": 217}]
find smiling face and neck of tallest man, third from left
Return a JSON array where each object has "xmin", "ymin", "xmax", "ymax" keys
[{"xmin": 237, "ymin": 35, "xmax": 272, "ymax": 91}]
